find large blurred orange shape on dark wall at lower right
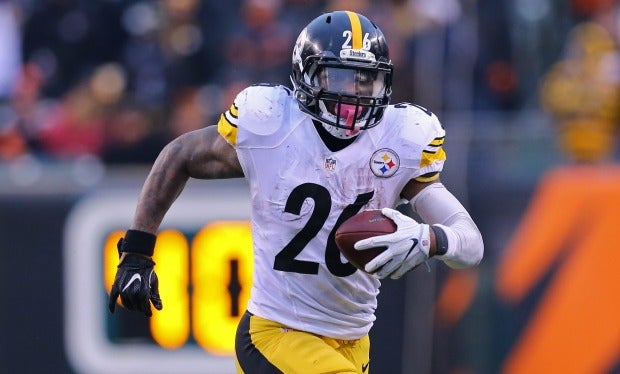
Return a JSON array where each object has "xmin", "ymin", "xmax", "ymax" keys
[{"xmin": 496, "ymin": 166, "xmax": 620, "ymax": 374}]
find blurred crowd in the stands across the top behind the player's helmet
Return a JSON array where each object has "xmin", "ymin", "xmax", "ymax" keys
[{"xmin": 0, "ymin": 0, "xmax": 620, "ymax": 165}]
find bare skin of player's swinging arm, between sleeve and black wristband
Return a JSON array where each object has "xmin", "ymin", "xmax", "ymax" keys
[{"xmin": 131, "ymin": 126, "xmax": 243, "ymax": 234}]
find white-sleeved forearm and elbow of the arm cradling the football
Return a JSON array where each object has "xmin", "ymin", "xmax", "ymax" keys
[{"xmin": 411, "ymin": 183, "xmax": 484, "ymax": 268}]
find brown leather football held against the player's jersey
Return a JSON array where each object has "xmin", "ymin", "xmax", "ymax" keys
[{"xmin": 335, "ymin": 209, "xmax": 396, "ymax": 270}]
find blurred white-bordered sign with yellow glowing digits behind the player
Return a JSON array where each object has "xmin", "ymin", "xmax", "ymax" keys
[{"xmin": 63, "ymin": 184, "xmax": 253, "ymax": 374}]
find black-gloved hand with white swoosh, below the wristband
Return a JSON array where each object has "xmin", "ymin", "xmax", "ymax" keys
[{"xmin": 108, "ymin": 242, "xmax": 163, "ymax": 317}]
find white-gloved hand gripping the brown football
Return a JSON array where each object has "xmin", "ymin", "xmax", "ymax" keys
[{"xmin": 355, "ymin": 208, "xmax": 430, "ymax": 279}]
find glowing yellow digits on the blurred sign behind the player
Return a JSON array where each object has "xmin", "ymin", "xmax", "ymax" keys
[{"xmin": 103, "ymin": 221, "xmax": 253, "ymax": 355}]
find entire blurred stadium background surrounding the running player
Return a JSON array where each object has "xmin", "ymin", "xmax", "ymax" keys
[{"xmin": 0, "ymin": 0, "xmax": 620, "ymax": 373}]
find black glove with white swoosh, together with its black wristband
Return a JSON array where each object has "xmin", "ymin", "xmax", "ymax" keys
[{"xmin": 108, "ymin": 230, "xmax": 163, "ymax": 317}]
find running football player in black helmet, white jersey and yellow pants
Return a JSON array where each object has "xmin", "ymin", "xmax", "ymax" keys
[{"xmin": 109, "ymin": 11, "xmax": 483, "ymax": 373}]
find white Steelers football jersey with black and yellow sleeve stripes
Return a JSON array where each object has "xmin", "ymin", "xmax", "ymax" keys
[{"xmin": 218, "ymin": 85, "xmax": 445, "ymax": 339}]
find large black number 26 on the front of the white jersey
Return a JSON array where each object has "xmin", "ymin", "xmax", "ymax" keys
[{"xmin": 273, "ymin": 183, "xmax": 374, "ymax": 277}]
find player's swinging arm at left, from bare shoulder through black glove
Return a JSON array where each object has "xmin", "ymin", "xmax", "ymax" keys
[{"xmin": 108, "ymin": 126, "xmax": 243, "ymax": 317}]
